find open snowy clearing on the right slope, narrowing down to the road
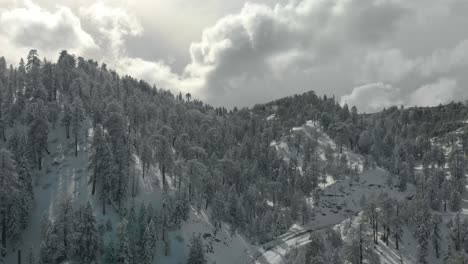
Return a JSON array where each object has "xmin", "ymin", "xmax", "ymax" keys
[{"xmin": 252, "ymin": 168, "xmax": 414, "ymax": 264}]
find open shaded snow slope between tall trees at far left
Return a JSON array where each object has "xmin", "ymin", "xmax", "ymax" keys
[{"xmin": 5, "ymin": 122, "xmax": 95, "ymax": 263}]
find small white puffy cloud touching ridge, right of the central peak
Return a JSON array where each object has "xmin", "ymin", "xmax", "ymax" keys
[{"xmin": 341, "ymin": 83, "xmax": 403, "ymax": 113}]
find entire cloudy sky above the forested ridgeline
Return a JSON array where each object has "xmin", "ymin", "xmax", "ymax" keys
[{"xmin": 0, "ymin": 0, "xmax": 468, "ymax": 112}]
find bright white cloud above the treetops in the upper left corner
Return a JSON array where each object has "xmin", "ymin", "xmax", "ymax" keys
[{"xmin": 0, "ymin": 1, "xmax": 98, "ymax": 60}]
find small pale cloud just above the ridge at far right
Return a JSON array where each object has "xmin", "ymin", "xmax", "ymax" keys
[{"xmin": 408, "ymin": 78, "xmax": 458, "ymax": 106}]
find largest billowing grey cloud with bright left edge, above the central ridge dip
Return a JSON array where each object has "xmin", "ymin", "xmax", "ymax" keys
[{"xmin": 176, "ymin": 0, "xmax": 406, "ymax": 105}]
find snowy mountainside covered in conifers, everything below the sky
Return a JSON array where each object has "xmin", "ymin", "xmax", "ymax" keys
[{"xmin": 0, "ymin": 50, "xmax": 468, "ymax": 264}]
